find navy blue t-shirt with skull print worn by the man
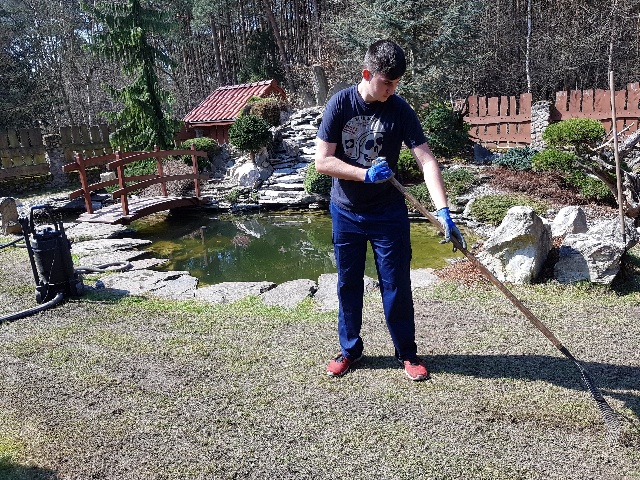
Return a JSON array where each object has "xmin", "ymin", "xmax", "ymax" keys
[{"xmin": 318, "ymin": 85, "xmax": 427, "ymax": 212}]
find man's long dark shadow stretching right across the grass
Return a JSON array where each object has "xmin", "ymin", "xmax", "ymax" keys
[{"xmin": 356, "ymin": 355, "xmax": 640, "ymax": 419}]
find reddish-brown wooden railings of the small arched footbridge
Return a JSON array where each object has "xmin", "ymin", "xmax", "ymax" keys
[{"xmin": 63, "ymin": 145, "xmax": 209, "ymax": 216}]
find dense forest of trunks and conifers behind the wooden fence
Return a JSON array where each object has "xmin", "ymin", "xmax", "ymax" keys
[{"xmin": 0, "ymin": 0, "xmax": 640, "ymax": 131}]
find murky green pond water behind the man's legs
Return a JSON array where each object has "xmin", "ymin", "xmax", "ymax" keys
[{"xmin": 132, "ymin": 210, "xmax": 460, "ymax": 285}]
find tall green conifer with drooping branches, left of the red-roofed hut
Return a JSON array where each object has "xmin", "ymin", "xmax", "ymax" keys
[{"xmin": 83, "ymin": 0, "xmax": 178, "ymax": 150}]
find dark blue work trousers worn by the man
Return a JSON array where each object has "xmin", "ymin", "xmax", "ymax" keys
[{"xmin": 330, "ymin": 202, "xmax": 417, "ymax": 359}]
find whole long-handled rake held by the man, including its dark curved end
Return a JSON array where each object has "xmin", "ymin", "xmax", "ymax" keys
[{"xmin": 389, "ymin": 177, "xmax": 621, "ymax": 442}]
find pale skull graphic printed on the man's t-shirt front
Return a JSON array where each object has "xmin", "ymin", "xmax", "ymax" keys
[{"xmin": 342, "ymin": 116, "xmax": 385, "ymax": 167}]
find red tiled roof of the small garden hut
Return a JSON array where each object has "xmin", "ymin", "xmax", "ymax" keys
[{"xmin": 184, "ymin": 80, "xmax": 285, "ymax": 124}]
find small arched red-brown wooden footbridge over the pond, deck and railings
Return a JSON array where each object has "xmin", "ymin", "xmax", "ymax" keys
[{"xmin": 63, "ymin": 146, "xmax": 209, "ymax": 225}]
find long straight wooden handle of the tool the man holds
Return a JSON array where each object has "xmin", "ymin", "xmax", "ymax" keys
[{"xmin": 389, "ymin": 177, "xmax": 568, "ymax": 355}]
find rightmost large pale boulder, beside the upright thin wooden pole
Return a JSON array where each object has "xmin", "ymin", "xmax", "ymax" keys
[{"xmin": 554, "ymin": 218, "xmax": 638, "ymax": 284}]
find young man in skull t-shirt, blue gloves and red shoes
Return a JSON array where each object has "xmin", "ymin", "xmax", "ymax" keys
[{"xmin": 315, "ymin": 40, "xmax": 464, "ymax": 380}]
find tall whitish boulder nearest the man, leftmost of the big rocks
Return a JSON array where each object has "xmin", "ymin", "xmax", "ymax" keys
[{"xmin": 478, "ymin": 206, "xmax": 551, "ymax": 284}]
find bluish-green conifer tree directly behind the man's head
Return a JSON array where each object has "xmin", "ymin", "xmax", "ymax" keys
[{"xmin": 330, "ymin": 0, "xmax": 484, "ymax": 107}]
